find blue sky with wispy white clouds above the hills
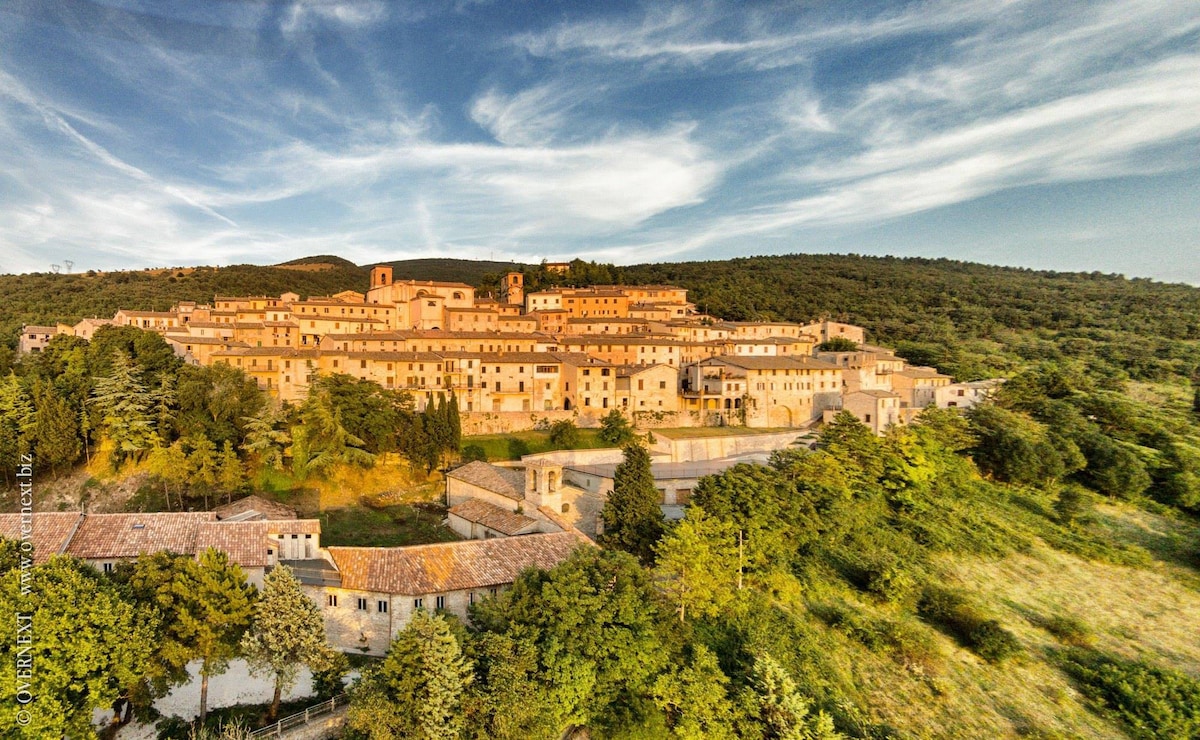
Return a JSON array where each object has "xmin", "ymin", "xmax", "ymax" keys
[{"xmin": 0, "ymin": 0, "xmax": 1200, "ymax": 284}]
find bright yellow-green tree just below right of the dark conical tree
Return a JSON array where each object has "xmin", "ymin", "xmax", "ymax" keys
[{"xmin": 654, "ymin": 505, "xmax": 738, "ymax": 622}]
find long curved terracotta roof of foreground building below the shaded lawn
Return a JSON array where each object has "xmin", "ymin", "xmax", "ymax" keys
[{"xmin": 329, "ymin": 533, "xmax": 584, "ymax": 596}]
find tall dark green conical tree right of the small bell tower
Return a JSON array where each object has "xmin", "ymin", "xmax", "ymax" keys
[{"xmin": 600, "ymin": 444, "xmax": 662, "ymax": 564}]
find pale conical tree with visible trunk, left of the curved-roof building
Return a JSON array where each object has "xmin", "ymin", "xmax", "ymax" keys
[{"xmin": 241, "ymin": 565, "xmax": 332, "ymax": 720}]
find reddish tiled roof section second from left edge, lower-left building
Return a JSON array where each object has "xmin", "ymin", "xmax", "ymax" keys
[{"xmin": 66, "ymin": 512, "xmax": 216, "ymax": 560}]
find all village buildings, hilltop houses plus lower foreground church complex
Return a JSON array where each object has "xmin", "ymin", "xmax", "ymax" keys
[{"xmin": 9, "ymin": 266, "xmax": 994, "ymax": 655}]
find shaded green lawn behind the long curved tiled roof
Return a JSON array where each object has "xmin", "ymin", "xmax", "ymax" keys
[{"xmin": 317, "ymin": 504, "xmax": 458, "ymax": 547}]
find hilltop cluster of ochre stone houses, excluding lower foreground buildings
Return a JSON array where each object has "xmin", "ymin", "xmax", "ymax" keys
[{"xmin": 20, "ymin": 266, "xmax": 989, "ymax": 434}]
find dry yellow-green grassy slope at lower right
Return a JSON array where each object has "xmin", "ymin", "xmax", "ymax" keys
[{"xmin": 804, "ymin": 505, "xmax": 1200, "ymax": 739}]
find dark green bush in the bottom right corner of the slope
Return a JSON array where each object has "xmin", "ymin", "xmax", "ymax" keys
[{"xmin": 1060, "ymin": 648, "xmax": 1200, "ymax": 740}]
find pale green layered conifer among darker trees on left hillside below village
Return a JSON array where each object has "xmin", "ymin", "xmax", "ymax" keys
[{"xmin": 91, "ymin": 351, "xmax": 156, "ymax": 463}]
